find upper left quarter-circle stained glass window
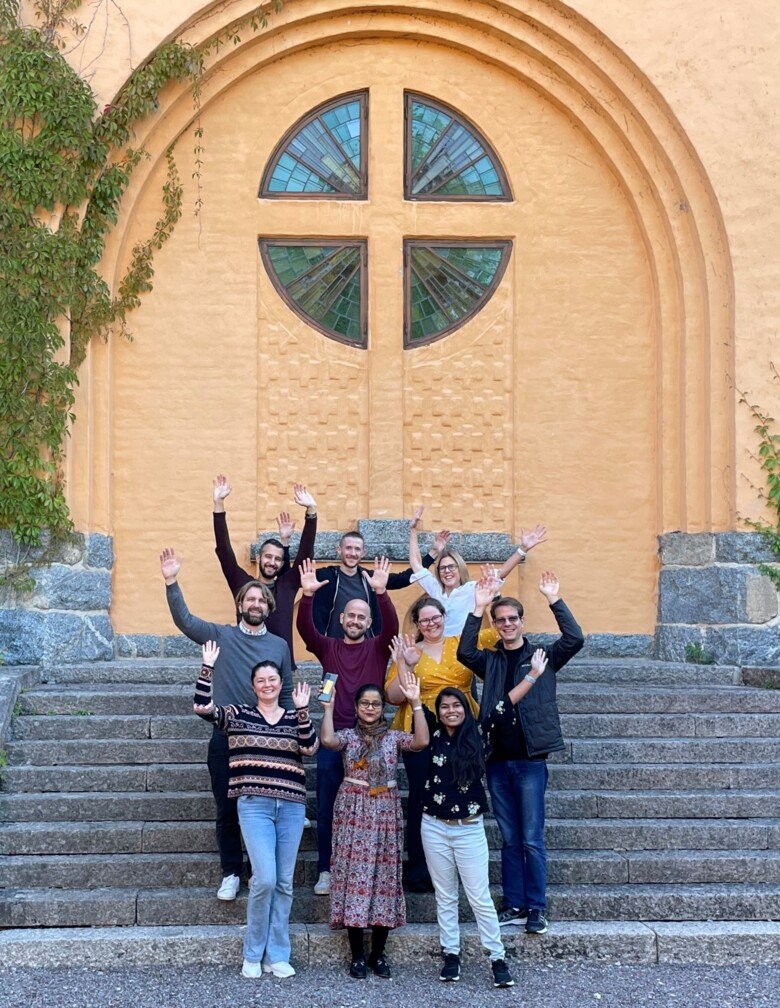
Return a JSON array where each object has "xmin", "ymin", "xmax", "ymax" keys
[{"xmin": 259, "ymin": 91, "xmax": 368, "ymax": 200}]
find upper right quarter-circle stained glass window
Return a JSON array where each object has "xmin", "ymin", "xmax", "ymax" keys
[{"xmin": 404, "ymin": 92, "xmax": 512, "ymax": 201}]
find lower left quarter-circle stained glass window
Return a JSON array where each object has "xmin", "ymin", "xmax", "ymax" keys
[{"xmin": 260, "ymin": 239, "xmax": 368, "ymax": 347}]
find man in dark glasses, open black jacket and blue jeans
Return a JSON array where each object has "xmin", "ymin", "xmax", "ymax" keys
[{"xmin": 458, "ymin": 571, "xmax": 584, "ymax": 934}]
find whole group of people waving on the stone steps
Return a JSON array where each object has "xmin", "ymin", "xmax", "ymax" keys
[{"xmin": 160, "ymin": 476, "xmax": 583, "ymax": 987}]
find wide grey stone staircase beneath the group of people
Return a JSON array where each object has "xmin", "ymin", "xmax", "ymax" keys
[{"xmin": 0, "ymin": 657, "xmax": 780, "ymax": 965}]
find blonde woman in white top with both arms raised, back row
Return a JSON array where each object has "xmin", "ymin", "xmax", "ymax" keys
[{"xmin": 409, "ymin": 507, "xmax": 547, "ymax": 637}]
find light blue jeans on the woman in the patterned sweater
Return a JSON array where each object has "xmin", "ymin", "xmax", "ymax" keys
[{"xmin": 238, "ymin": 794, "xmax": 305, "ymax": 963}]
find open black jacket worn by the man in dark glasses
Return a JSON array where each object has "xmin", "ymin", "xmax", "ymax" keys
[{"xmin": 458, "ymin": 599, "xmax": 584, "ymax": 756}]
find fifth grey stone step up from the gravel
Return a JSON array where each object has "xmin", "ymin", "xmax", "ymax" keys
[{"xmin": 0, "ymin": 789, "xmax": 780, "ymax": 823}]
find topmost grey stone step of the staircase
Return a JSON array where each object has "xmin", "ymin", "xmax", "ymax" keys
[{"xmin": 42, "ymin": 655, "xmax": 741, "ymax": 687}]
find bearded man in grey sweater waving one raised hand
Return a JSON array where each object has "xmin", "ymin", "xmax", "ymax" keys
[{"xmin": 160, "ymin": 549, "xmax": 293, "ymax": 900}]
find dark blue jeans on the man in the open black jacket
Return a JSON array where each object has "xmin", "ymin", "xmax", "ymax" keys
[{"xmin": 488, "ymin": 759, "xmax": 547, "ymax": 910}]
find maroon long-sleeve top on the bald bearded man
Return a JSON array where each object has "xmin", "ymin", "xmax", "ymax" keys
[{"xmin": 297, "ymin": 592, "xmax": 398, "ymax": 731}]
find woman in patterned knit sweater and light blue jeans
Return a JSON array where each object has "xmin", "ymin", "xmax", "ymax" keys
[{"xmin": 193, "ymin": 641, "xmax": 318, "ymax": 978}]
